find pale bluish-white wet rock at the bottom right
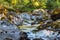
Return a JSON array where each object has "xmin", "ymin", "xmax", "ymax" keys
[{"xmin": 27, "ymin": 29, "xmax": 58, "ymax": 40}]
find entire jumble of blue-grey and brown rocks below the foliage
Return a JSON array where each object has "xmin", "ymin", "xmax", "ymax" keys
[{"xmin": 0, "ymin": 9, "xmax": 60, "ymax": 40}]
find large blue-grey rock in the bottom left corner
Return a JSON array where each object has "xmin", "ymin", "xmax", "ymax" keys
[{"xmin": 0, "ymin": 21, "xmax": 20, "ymax": 40}]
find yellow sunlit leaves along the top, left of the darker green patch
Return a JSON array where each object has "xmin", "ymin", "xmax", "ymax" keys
[{"xmin": 2, "ymin": 0, "xmax": 46, "ymax": 10}]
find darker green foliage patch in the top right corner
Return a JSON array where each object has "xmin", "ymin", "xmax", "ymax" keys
[{"xmin": 46, "ymin": 0, "xmax": 60, "ymax": 9}]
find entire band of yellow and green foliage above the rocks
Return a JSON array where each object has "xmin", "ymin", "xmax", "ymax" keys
[{"xmin": 0, "ymin": 0, "xmax": 60, "ymax": 11}]
